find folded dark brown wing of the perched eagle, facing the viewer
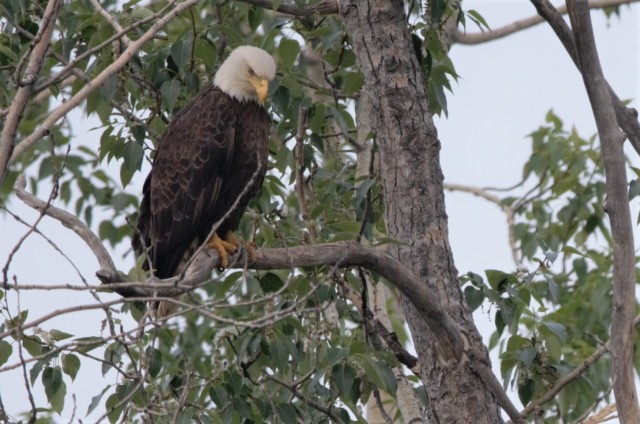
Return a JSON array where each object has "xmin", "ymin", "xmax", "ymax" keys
[{"xmin": 134, "ymin": 87, "xmax": 238, "ymax": 278}]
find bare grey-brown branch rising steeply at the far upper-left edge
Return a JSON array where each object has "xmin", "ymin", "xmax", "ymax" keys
[{"xmin": 0, "ymin": 0, "xmax": 62, "ymax": 182}]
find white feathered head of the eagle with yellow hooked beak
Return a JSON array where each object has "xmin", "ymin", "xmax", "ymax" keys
[{"xmin": 213, "ymin": 46, "xmax": 276, "ymax": 103}]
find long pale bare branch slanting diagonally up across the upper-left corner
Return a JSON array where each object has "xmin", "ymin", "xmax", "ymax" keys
[{"xmin": 6, "ymin": 0, "xmax": 197, "ymax": 169}]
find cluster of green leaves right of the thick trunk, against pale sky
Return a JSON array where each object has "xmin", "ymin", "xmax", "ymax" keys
[{"xmin": 462, "ymin": 111, "xmax": 640, "ymax": 423}]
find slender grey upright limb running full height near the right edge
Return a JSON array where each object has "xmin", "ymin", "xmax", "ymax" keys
[{"xmin": 567, "ymin": 0, "xmax": 640, "ymax": 423}]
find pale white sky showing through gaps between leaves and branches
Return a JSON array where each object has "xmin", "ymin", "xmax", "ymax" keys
[{"xmin": 0, "ymin": 0, "xmax": 640, "ymax": 422}]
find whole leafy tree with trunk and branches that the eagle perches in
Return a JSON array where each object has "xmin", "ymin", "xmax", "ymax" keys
[{"xmin": 0, "ymin": 0, "xmax": 640, "ymax": 423}]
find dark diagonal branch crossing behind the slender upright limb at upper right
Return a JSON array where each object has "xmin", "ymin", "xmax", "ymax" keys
[{"xmin": 530, "ymin": 0, "xmax": 640, "ymax": 154}]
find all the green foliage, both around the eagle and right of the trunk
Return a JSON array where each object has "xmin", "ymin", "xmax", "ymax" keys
[{"xmin": 0, "ymin": 0, "xmax": 640, "ymax": 423}]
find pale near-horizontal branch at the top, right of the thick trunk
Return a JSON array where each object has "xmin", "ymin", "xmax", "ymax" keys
[{"xmin": 451, "ymin": 0, "xmax": 640, "ymax": 45}]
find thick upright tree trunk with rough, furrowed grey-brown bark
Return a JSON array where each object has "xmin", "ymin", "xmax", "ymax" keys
[{"xmin": 339, "ymin": 0, "xmax": 502, "ymax": 423}]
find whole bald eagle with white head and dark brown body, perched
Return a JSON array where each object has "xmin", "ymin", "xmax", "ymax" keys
[{"xmin": 133, "ymin": 46, "xmax": 276, "ymax": 306}]
